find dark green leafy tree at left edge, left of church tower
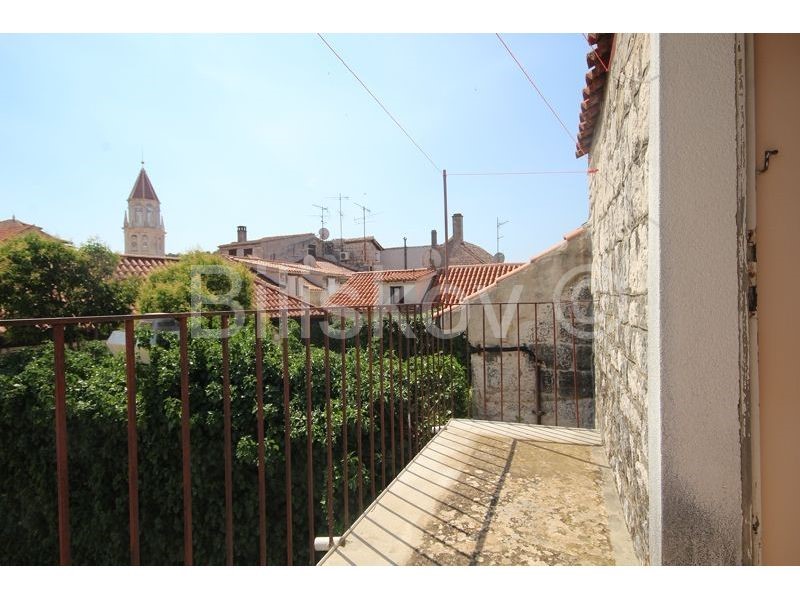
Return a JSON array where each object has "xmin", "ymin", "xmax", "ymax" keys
[{"xmin": 0, "ymin": 234, "xmax": 136, "ymax": 343}]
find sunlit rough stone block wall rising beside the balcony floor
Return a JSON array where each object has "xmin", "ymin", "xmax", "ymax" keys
[{"xmin": 589, "ymin": 34, "xmax": 650, "ymax": 563}]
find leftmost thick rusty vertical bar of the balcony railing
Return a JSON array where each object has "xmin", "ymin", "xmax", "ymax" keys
[{"xmin": 53, "ymin": 325, "xmax": 72, "ymax": 565}]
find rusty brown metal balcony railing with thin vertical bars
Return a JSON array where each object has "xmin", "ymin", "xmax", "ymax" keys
[{"xmin": 0, "ymin": 302, "xmax": 593, "ymax": 565}]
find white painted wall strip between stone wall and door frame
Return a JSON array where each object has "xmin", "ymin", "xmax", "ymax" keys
[{"xmin": 648, "ymin": 34, "xmax": 742, "ymax": 564}]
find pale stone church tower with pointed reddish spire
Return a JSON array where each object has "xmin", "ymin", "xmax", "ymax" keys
[{"xmin": 122, "ymin": 163, "xmax": 166, "ymax": 256}]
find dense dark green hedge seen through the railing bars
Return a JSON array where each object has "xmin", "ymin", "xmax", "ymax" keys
[{"xmin": 0, "ymin": 316, "xmax": 468, "ymax": 565}]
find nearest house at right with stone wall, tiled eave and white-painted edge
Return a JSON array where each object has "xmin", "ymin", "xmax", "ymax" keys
[{"xmin": 577, "ymin": 34, "xmax": 800, "ymax": 564}]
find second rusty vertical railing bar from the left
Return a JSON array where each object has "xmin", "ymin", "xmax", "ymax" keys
[{"xmin": 125, "ymin": 320, "xmax": 140, "ymax": 565}]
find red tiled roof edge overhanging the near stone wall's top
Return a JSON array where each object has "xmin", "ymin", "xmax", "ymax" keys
[{"xmin": 575, "ymin": 33, "xmax": 614, "ymax": 158}]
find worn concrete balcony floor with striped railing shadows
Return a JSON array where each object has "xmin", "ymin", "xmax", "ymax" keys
[{"xmin": 319, "ymin": 419, "xmax": 638, "ymax": 565}]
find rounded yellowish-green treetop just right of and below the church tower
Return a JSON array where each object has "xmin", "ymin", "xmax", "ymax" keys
[{"xmin": 138, "ymin": 252, "xmax": 253, "ymax": 313}]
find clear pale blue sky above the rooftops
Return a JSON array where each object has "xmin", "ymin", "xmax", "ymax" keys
[{"xmin": 0, "ymin": 34, "xmax": 588, "ymax": 260}]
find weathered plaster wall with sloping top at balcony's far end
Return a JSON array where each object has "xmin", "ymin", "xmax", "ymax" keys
[{"xmin": 455, "ymin": 229, "xmax": 595, "ymax": 427}]
